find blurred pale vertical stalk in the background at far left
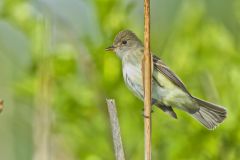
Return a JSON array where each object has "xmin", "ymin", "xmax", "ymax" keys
[{"xmin": 33, "ymin": 17, "xmax": 51, "ymax": 160}]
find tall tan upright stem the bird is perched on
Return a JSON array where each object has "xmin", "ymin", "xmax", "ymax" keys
[{"xmin": 143, "ymin": 0, "xmax": 152, "ymax": 160}]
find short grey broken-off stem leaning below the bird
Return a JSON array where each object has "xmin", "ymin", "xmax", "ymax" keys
[{"xmin": 106, "ymin": 99, "xmax": 125, "ymax": 160}]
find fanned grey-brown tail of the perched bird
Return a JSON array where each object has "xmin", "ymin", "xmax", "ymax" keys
[{"xmin": 192, "ymin": 97, "xmax": 227, "ymax": 130}]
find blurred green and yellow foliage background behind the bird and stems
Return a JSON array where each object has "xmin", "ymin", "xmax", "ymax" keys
[{"xmin": 0, "ymin": 0, "xmax": 240, "ymax": 160}]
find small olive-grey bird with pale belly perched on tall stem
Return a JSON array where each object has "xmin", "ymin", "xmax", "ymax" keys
[{"xmin": 106, "ymin": 30, "xmax": 227, "ymax": 130}]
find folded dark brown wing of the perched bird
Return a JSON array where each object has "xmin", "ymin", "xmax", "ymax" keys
[{"xmin": 153, "ymin": 55, "xmax": 191, "ymax": 96}]
